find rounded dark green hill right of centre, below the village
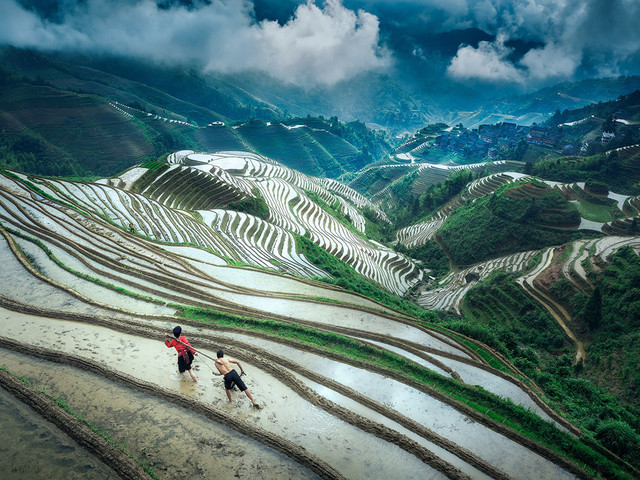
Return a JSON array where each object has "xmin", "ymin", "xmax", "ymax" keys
[{"xmin": 438, "ymin": 182, "xmax": 587, "ymax": 265}]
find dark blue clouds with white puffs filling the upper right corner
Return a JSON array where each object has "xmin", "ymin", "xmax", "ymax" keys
[{"xmin": 345, "ymin": 0, "xmax": 640, "ymax": 87}]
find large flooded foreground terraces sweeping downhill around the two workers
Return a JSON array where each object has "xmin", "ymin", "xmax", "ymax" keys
[{"xmin": 0, "ymin": 166, "xmax": 596, "ymax": 479}]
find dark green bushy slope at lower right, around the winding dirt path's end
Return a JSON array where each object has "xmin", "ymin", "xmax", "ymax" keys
[{"xmin": 452, "ymin": 258, "xmax": 640, "ymax": 467}]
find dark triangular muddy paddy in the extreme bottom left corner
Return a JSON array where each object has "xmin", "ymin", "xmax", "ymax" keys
[{"xmin": 0, "ymin": 386, "xmax": 118, "ymax": 480}]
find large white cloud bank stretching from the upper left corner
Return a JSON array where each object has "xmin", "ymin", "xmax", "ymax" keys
[{"xmin": 0, "ymin": 0, "xmax": 391, "ymax": 85}]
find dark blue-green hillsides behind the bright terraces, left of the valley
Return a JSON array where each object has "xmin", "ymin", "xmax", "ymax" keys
[{"xmin": 0, "ymin": 79, "xmax": 386, "ymax": 177}]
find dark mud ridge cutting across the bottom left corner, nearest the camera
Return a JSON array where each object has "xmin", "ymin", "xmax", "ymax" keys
[{"xmin": 0, "ymin": 370, "xmax": 150, "ymax": 480}]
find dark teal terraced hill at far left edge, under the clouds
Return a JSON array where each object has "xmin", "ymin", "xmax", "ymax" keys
[{"xmin": 0, "ymin": 82, "xmax": 158, "ymax": 175}]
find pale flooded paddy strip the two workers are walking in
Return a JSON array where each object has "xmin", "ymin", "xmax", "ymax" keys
[{"xmin": 0, "ymin": 310, "xmax": 448, "ymax": 479}]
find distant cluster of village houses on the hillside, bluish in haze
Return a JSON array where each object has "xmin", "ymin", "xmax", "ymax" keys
[{"xmin": 434, "ymin": 122, "xmax": 573, "ymax": 158}]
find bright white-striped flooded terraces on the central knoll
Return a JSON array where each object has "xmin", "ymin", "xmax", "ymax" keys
[{"xmin": 165, "ymin": 151, "xmax": 422, "ymax": 294}]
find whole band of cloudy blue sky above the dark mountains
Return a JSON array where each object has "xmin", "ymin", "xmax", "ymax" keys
[{"xmin": 0, "ymin": 0, "xmax": 640, "ymax": 91}]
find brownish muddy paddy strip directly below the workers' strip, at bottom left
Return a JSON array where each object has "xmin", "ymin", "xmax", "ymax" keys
[{"xmin": 0, "ymin": 349, "xmax": 317, "ymax": 480}]
